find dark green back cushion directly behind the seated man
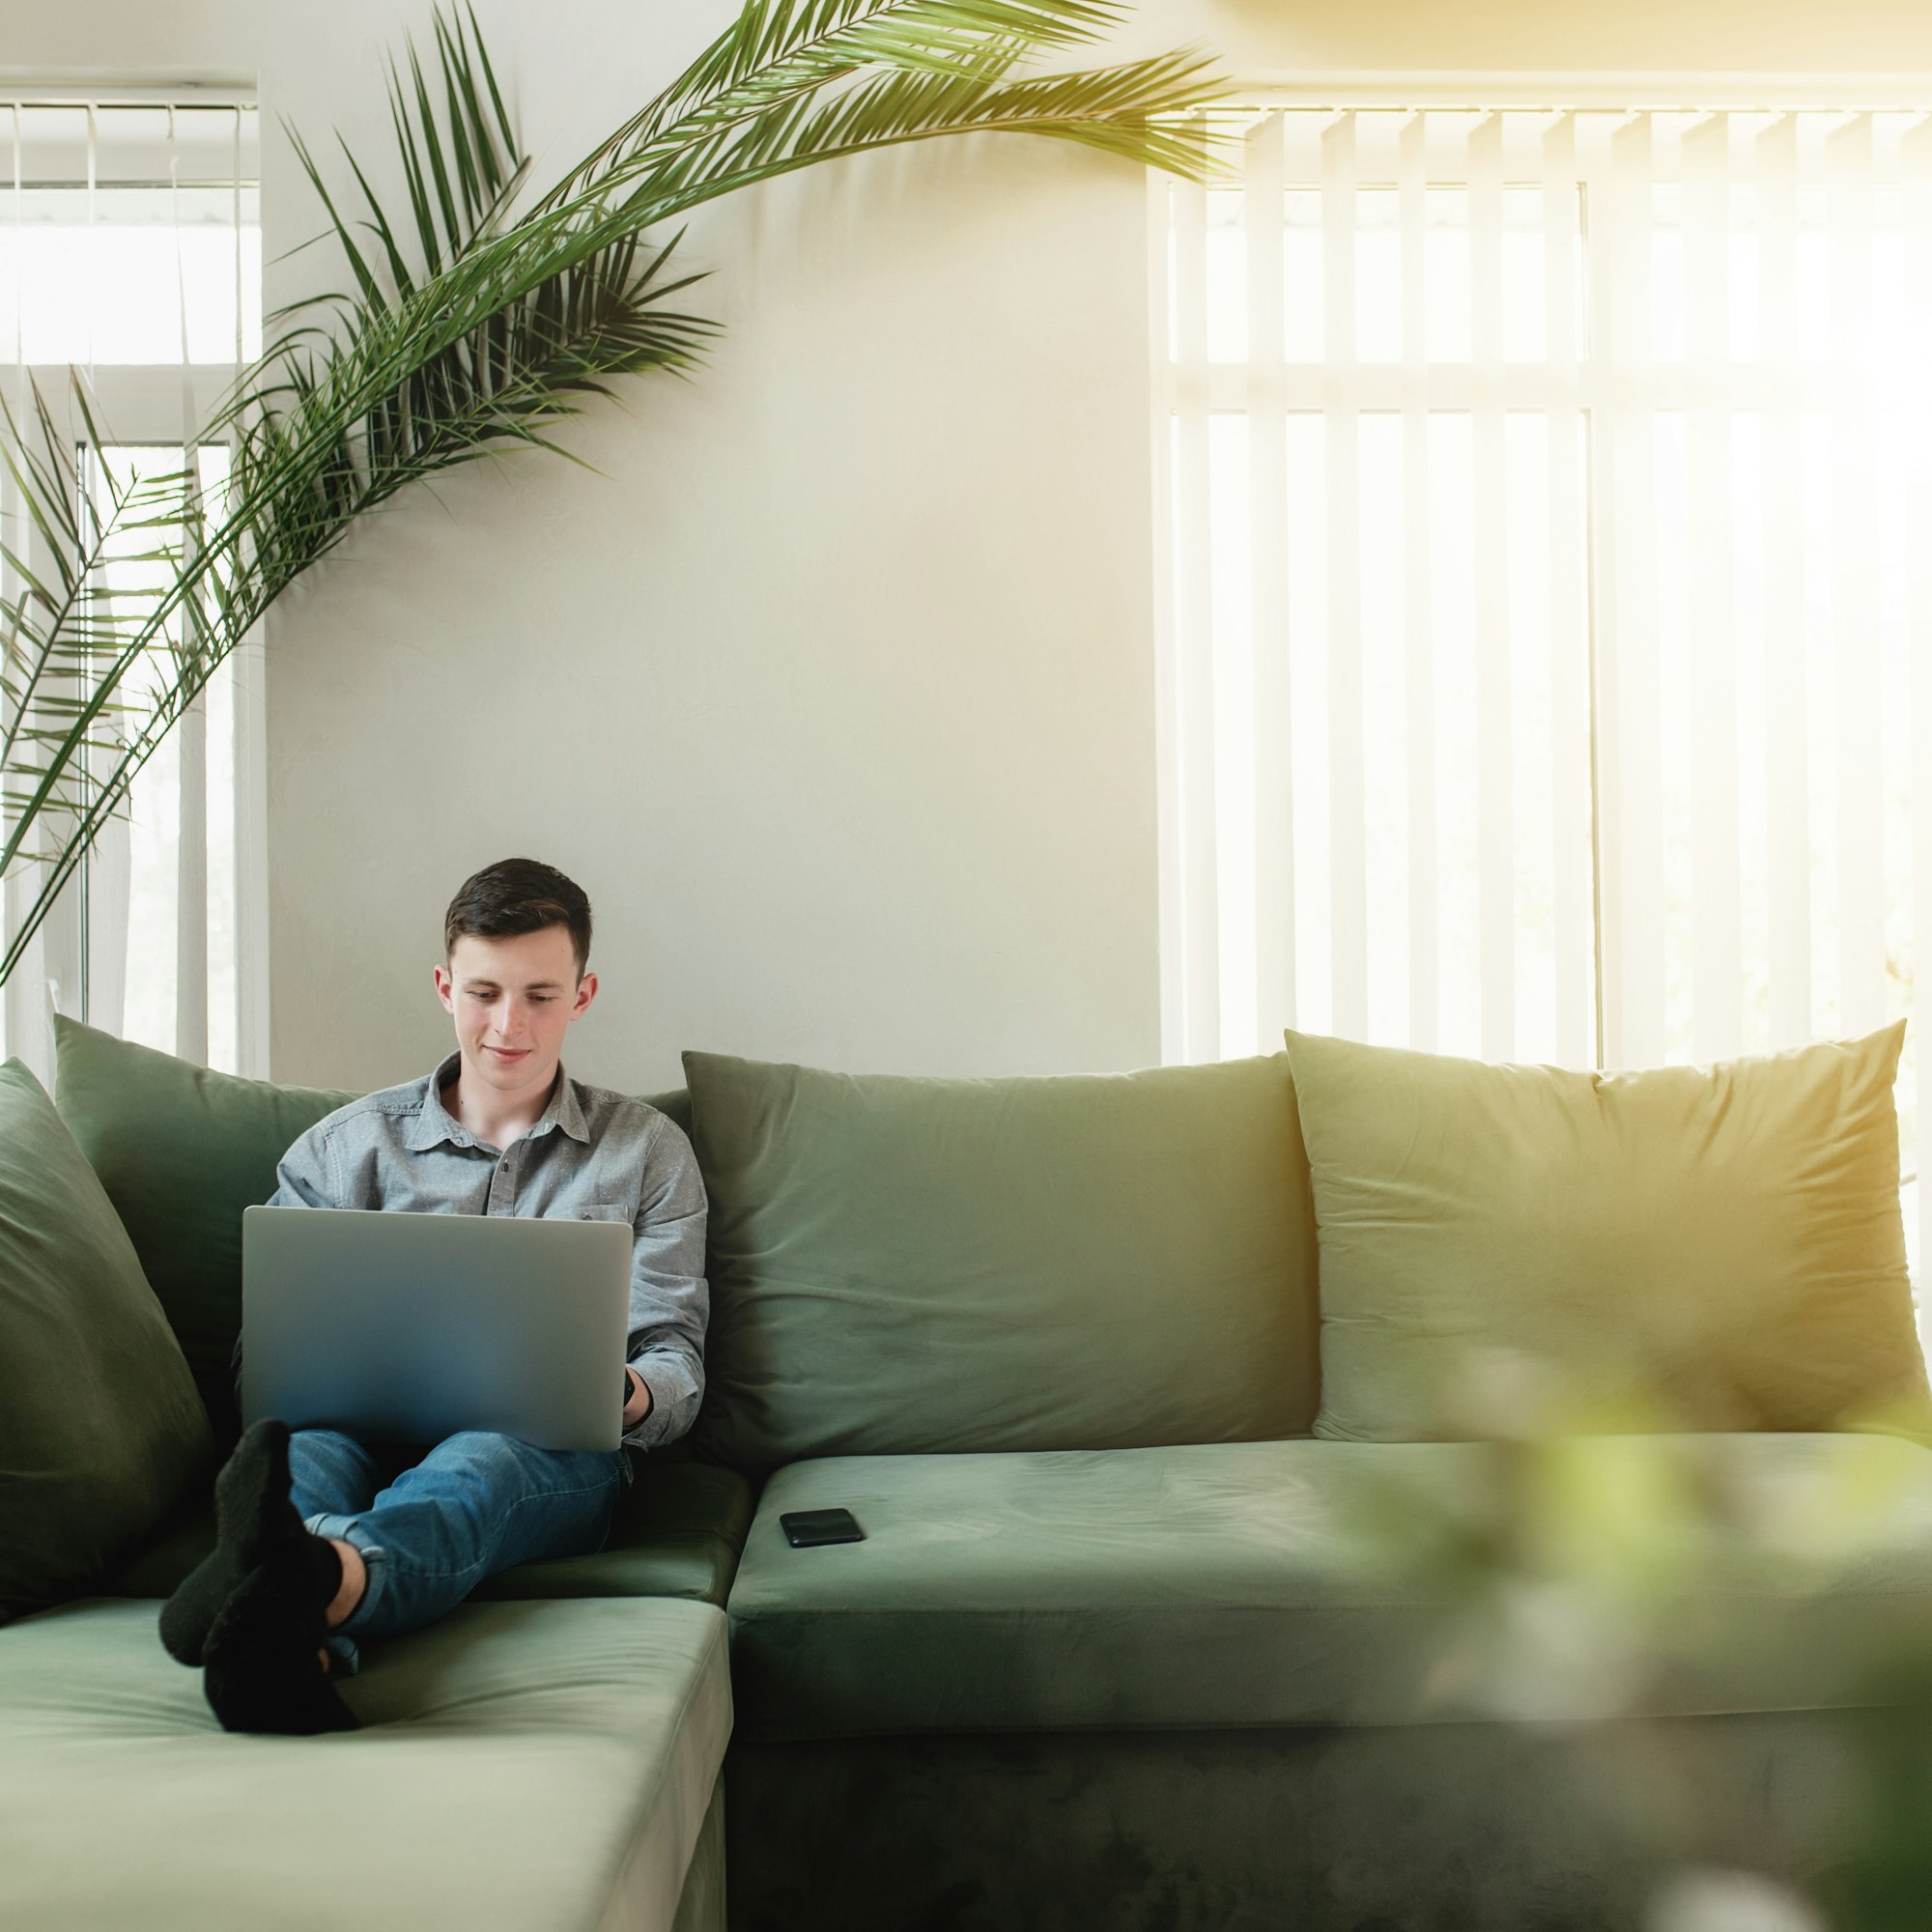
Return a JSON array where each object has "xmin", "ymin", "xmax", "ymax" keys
[{"xmin": 54, "ymin": 1018, "xmax": 690, "ymax": 1441}]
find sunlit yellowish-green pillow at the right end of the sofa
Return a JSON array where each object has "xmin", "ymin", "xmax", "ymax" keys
[{"xmin": 1287, "ymin": 1022, "xmax": 1932, "ymax": 1441}]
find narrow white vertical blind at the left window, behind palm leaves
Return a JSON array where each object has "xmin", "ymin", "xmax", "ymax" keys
[{"xmin": 0, "ymin": 99, "xmax": 267, "ymax": 1074}]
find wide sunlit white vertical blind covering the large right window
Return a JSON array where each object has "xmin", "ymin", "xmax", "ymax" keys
[{"xmin": 1151, "ymin": 108, "xmax": 1932, "ymax": 1254}]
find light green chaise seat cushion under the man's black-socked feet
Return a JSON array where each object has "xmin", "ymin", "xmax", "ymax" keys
[{"xmin": 0, "ymin": 1598, "xmax": 730, "ymax": 1932}]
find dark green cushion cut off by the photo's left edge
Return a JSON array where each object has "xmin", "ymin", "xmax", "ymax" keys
[{"xmin": 0, "ymin": 1061, "xmax": 213, "ymax": 1621}]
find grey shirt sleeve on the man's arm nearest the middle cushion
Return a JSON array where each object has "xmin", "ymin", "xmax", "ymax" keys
[{"xmin": 624, "ymin": 1117, "xmax": 711, "ymax": 1449}]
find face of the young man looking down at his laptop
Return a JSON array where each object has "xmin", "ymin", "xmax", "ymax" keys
[{"xmin": 437, "ymin": 925, "xmax": 597, "ymax": 1099}]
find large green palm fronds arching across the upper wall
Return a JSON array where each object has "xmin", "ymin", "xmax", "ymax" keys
[{"xmin": 0, "ymin": 0, "xmax": 1219, "ymax": 983}]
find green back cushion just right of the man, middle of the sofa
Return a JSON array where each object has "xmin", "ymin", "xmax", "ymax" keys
[{"xmin": 684, "ymin": 1053, "xmax": 1316, "ymax": 1468}]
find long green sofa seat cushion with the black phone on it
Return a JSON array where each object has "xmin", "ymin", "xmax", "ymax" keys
[{"xmin": 728, "ymin": 1435, "xmax": 1932, "ymax": 1741}]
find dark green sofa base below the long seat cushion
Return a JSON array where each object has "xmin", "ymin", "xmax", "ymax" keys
[{"xmin": 724, "ymin": 1712, "xmax": 1870, "ymax": 1932}]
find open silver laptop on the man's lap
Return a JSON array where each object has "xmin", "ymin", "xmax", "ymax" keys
[{"xmin": 242, "ymin": 1208, "xmax": 632, "ymax": 1449}]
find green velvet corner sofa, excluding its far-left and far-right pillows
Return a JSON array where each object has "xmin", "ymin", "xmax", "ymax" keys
[{"xmin": 0, "ymin": 1024, "xmax": 1932, "ymax": 1932}]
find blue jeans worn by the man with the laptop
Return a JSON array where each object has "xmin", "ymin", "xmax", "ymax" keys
[{"xmin": 288, "ymin": 1430, "xmax": 630, "ymax": 1675}]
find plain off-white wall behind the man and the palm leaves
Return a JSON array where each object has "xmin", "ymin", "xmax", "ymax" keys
[{"xmin": 6, "ymin": 0, "xmax": 1932, "ymax": 1088}]
